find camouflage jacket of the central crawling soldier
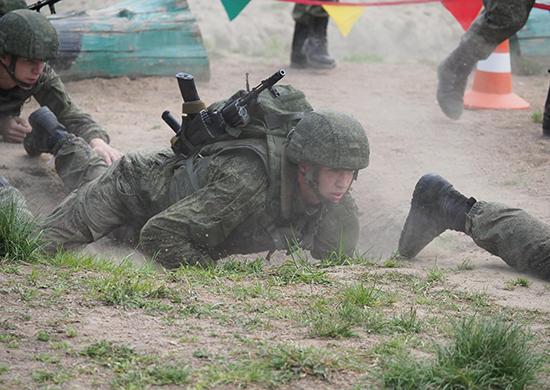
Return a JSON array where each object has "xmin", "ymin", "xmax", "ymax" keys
[{"xmin": 141, "ymin": 142, "xmax": 359, "ymax": 268}]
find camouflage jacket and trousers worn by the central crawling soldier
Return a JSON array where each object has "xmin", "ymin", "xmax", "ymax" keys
[{"xmin": 43, "ymin": 142, "xmax": 359, "ymax": 268}]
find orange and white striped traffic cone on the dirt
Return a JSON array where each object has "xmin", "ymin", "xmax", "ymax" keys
[{"xmin": 464, "ymin": 40, "xmax": 529, "ymax": 110}]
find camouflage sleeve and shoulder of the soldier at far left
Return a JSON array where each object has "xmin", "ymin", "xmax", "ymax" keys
[{"xmin": 0, "ymin": 64, "xmax": 110, "ymax": 143}]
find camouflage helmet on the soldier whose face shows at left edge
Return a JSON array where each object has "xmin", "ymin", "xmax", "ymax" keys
[{"xmin": 0, "ymin": 9, "xmax": 59, "ymax": 61}]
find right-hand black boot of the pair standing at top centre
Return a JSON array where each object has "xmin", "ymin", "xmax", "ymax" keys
[{"xmin": 304, "ymin": 16, "xmax": 336, "ymax": 69}]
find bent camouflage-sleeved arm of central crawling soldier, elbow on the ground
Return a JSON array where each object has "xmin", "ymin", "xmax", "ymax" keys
[{"xmin": 141, "ymin": 151, "xmax": 267, "ymax": 269}]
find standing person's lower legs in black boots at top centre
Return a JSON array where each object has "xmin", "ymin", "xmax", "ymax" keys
[{"xmin": 290, "ymin": 0, "xmax": 338, "ymax": 69}]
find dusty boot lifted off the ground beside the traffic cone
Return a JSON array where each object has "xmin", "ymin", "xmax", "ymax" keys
[{"xmin": 437, "ymin": 46, "xmax": 476, "ymax": 119}]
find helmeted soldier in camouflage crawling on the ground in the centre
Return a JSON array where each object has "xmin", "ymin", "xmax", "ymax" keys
[{"xmin": 2, "ymin": 110, "xmax": 369, "ymax": 268}]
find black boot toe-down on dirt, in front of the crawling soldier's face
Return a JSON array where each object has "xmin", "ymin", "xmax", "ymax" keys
[{"xmin": 398, "ymin": 173, "xmax": 476, "ymax": 258}]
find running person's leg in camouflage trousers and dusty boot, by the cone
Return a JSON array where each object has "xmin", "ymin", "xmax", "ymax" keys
[{"xmin": 437, "ymin": 0, "xmax": 535, "ymax": 119}]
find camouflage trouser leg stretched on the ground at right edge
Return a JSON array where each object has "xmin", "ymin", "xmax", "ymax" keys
[{"xmin": 466, "ymin": 202, "xmax": 550, "ymax": 279}]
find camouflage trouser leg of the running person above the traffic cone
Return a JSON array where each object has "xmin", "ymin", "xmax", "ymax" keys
[{"xmin": 457, "ymin": 0, "xmax": 535, "ymax": 62}]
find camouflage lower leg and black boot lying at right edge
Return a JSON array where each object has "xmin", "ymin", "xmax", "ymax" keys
[{"xmin": 398, "ymin": 173, "xmax": 550, "ymax": 280}]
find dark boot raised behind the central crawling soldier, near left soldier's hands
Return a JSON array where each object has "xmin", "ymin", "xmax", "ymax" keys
[{"xmin": 23, "ymin": 106, "xmax": 69, "ymax": 156}]
